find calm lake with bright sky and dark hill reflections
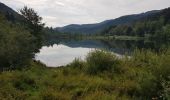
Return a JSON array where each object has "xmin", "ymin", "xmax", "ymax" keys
[{"xmin": 35, "ymin": 40, "xmax": 166, "ymax": 67}]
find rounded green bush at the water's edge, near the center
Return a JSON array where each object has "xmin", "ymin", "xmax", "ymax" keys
[{"xmin": 86, "ymin": 50, "xmax": 120, "ymax": 74}]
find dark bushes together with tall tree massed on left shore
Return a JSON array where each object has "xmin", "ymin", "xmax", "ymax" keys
[{"xmin": 0, "ymin": 7, "xmax": 43, "ymax": 71}]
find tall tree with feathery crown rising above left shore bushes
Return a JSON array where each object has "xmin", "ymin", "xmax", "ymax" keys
[{"xmin": 20, "ymin": 6, "xmax": 44, "ymax": 52}]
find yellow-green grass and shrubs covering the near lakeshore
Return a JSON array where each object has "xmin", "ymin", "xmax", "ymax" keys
[{"xmin": 0, "ymin": 50, "xmax": 170, "ymax": 100}]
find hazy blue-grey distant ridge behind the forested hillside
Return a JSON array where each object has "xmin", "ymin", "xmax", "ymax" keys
[{"xmin": 56, "ymin": 10, "xmax": 159, "ymax": 34}]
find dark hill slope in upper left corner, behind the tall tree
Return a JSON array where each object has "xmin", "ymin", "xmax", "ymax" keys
[{"xmin": 0, "ymin": 2, "xmax": 23, "ymax": 20}]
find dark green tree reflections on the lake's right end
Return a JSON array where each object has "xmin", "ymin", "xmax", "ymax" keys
[{"xmin": 102, "ymin": 40, "xmax": 170, "ymax": 51}]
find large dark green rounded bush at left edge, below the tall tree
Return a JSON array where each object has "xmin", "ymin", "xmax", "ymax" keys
[{"xmin": 0, "ymin": 14, "xmax": 36, "ymax": 70}]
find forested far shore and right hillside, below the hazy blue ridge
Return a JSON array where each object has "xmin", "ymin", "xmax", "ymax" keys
[{"xmin": 45, "ymin": 8, "xmax": 170, "ymax": 42}]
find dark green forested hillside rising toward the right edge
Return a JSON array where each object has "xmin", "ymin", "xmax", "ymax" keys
[{"xmin": 101, "ymin": 8, "xmax": 170, "ymax": 40}]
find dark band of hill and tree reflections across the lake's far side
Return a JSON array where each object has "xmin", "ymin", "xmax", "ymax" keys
[{"xmin": 44, "ymin": 39, "xmax": 170, "ymax": 54}]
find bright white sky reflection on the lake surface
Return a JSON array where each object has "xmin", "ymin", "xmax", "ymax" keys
[{"xmin": 36, "ymin": 44, "xmax": 94, "ymax": 67}]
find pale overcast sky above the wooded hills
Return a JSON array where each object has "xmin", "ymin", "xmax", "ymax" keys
[{"xmin": 0, "ymin": 0, "xmax": 170, "ymax": 27}]
